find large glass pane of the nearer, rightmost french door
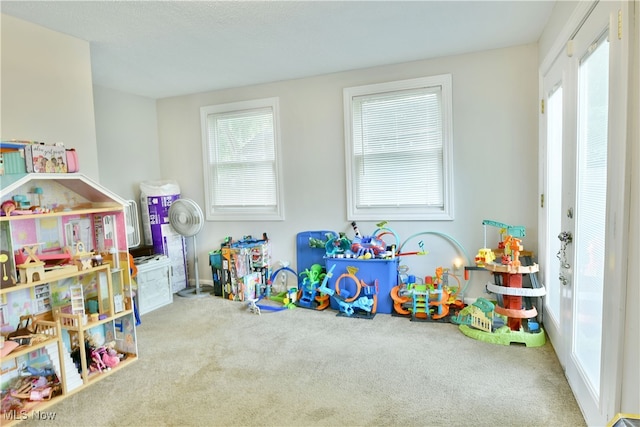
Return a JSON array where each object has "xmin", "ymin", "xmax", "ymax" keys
[{"xmin": 573, "ymin": 33, "xmax": 609, "ymax": 396}]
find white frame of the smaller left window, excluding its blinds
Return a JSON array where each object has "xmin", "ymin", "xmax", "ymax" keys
[{"xmin": 200, "ymin": 97, "xmax": 284, "ymax": 221}]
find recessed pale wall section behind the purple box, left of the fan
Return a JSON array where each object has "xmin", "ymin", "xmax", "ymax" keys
[{"xmin": 93, "ymin": 85, "xmax": 161, "ymax": 202}]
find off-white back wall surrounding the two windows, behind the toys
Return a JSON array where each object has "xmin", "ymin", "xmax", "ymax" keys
[{"xmin": 157, "ymin": 44, "xmax": 538, "ymax": 295}]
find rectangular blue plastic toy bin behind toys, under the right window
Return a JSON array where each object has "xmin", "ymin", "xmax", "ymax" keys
[{"xmin": 325, "ymin": 258, "xmax": 398, "ymax": 314}]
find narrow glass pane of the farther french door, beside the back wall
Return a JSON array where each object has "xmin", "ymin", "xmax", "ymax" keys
[{"xmin": 545, "ymin": 86, "xmax": 562, "ymax": 322}]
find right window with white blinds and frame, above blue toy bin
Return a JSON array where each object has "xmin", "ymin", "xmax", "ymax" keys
[{"xmin": 344, "ymin": 75, "xmax": 453, "ymax": 220}]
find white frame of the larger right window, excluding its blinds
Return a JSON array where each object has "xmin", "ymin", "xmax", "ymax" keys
[{"xmin": 343, "ymin": 74, "xmax": 454, "ymax": 221}]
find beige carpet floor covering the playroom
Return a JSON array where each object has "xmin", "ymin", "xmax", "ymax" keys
[{"xmin": 24, "ymin": 296, "xmax": 585, "ymax": 426}]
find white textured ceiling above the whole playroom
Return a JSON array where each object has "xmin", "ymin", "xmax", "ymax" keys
[{"xmin": 0, "ymin": 0, "xmax": 555, "ymax": 98}]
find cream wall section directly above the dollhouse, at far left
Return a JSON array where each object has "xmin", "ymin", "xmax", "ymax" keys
[{"xmin": 0, "ymin": 15, "xmax": 98, "ymax": 181}]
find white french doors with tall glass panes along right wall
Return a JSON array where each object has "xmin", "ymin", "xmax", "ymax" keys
[{"xmin": 540, "ymin": 1, "xmax": 626, "ymax": 425}]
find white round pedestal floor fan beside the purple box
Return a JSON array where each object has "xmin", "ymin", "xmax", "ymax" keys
[{"xmin": 169, "ymin": 199, "xmax": 213, "ymax": 298}]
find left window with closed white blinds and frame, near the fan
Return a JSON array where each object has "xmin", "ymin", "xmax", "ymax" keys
[{"xmin": 200, "ymin": 98, "xmax": 284, "ymax": 220}]
